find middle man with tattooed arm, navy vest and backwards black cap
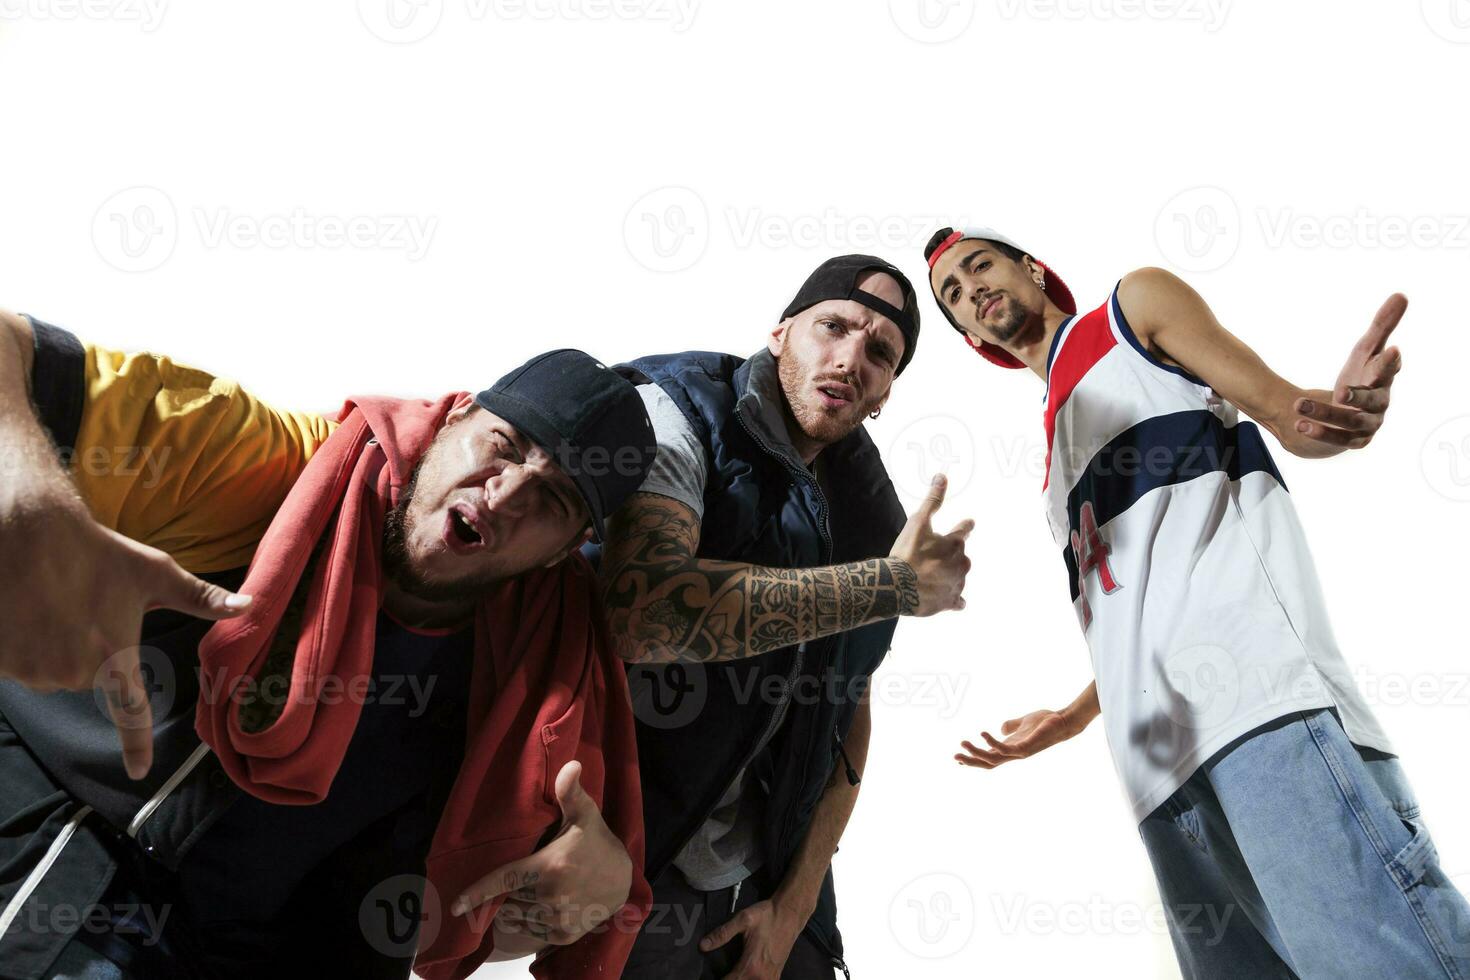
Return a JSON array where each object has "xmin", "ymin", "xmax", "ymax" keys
[{"xmin": 600, "ymin": 256, "xmax": 973, "ymax": 980}]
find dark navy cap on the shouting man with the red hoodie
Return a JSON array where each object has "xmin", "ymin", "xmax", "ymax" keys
[{"xmin": 475, "ymin": 348, "xmax": 657, "ymax": 541}]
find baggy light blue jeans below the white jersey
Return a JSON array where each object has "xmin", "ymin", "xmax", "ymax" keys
[{"xmin": 1139, "ymin": 710, "xmax": 1470, "ymax": 980}]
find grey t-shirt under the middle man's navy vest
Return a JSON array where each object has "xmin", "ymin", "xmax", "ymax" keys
[{"xmin": 638, "ymin": 385, "xmax": 784, "ymax": 892}]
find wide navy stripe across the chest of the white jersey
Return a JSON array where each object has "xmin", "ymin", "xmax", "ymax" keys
[{"xmin": 1061, "ymin": 408, "xmax": 1286, "ymax": 601}]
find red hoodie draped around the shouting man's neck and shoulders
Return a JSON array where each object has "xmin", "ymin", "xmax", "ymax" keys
[{"xmin": 196, "ymin": 394, "xmax": 653, "ymax": 980}]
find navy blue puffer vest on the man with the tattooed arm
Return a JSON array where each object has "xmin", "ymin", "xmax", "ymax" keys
[{"xmin": 611, "ymin": 351, "xmax": 904, "ymax": 954}]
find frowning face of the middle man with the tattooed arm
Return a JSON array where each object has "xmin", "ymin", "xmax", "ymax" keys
[{"xmin": 769, "ymin": 264, "xmax": 904, "ymax": 461}]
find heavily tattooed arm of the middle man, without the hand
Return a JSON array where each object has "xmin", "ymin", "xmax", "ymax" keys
[{"xmin": 603, "ymin": 494, "xmax": 919, "ymax": 661}]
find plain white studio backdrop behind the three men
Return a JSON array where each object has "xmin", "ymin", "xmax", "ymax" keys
[{"xmin": 0, "ymin": 0, "xmax": 1470, "ymax": 979}]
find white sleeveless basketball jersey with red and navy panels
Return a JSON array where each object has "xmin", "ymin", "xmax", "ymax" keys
[{"xmin": 1044, "ymin": 283, "xmax": 1392, "ymax": 820}]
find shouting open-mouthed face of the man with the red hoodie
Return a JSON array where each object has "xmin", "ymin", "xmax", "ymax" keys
[{"xmin": 384, "ymin": 395, "xmax": 591, "ymax": 602}]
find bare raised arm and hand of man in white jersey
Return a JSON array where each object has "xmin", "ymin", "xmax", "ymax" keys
[{"xmin": 1119, "ymin": 269, "xmax": 1408, "ymax": 458}]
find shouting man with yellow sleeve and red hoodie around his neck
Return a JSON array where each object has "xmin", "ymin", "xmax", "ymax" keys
[{"xmin": 0, "ymin": 313, "xmax": 654, "ymax": 980}]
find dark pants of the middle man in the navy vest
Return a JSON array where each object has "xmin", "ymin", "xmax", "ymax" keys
[{"xmin": 623, "ymin": 867, "xmax": 836, "ymax": 980}]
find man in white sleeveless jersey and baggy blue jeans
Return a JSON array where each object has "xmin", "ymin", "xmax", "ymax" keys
[{"xmin": 925, "ymin": 228, "xmax": 1470, "ymax": 979}]
